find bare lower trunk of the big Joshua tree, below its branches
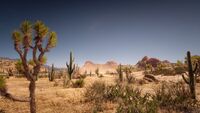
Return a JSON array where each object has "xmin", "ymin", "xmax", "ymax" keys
[{"xmin": 29, "ymin": 79, "xmax": 36, "ymax": 113}]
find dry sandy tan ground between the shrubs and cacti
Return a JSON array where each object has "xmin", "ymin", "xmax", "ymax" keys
[{"xmin": 0, "ymin": 72, "xmax": 200, "ymax": 113}]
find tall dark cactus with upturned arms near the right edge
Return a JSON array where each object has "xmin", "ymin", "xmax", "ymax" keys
[{"xmin": 182, "ymin": 51, "xmax": 198, "ymax": 99}]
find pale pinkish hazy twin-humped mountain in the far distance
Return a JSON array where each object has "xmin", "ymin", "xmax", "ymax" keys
[{"xmin": 80, "ymin": 61, "xmax": 118, "ymax": 74}]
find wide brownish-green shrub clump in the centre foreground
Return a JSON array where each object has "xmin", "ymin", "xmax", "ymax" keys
[{"xmin": 85, "ymin": 82, "xmax": 157, "ymax": 113}]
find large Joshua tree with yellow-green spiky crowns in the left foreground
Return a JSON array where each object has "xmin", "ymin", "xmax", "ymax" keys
[{"xmin": 12, "ymin": 21, "xmax": 57, "ymax": 113}]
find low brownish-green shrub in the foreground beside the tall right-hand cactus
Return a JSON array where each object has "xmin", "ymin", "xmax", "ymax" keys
[{"xmin": 153, "ymin": 82, "xmax": 199, "ymax": 112}]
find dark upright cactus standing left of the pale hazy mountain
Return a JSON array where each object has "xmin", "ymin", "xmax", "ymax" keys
[{"xmin": 66, "ymin": 51, "xmax": 76, "ymax": 80}]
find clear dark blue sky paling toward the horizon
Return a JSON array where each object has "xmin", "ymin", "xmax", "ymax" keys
[{"xmin": 0, "ymin": 0, "xmax": 200, "ymax": 67}]
